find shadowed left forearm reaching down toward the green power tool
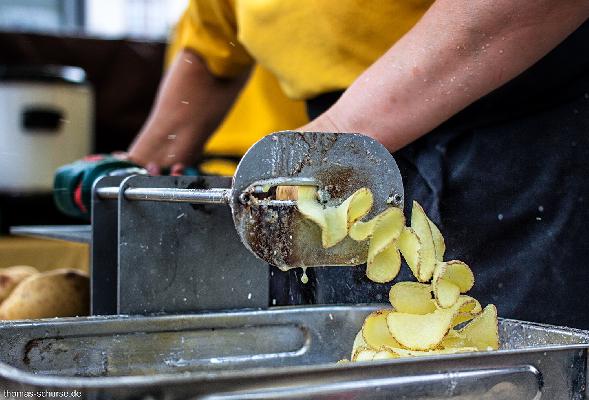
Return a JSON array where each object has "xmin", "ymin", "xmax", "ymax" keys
[{"xmin": 128, "ymin": 50, "xmax": 246, "ymax": 174}]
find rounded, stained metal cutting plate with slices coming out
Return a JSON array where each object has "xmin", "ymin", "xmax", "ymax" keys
[{"xmin": 230, "ymin": 131, "xmax": 403, "ymax": 269}]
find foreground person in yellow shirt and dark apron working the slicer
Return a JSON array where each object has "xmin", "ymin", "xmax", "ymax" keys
[{"xmin": 129, "ymin": 0, "xmax": 589, "ymax": 328}]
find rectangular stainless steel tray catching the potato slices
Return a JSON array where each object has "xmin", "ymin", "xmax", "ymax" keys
[{"xmin": 0, "ymin": 305, "xmax": 589, "ymax": 400}]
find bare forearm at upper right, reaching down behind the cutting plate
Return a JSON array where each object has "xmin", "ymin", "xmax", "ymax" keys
[{"xmin": 301, "ymin": 0, "xmax": 589, "ymax": 151}]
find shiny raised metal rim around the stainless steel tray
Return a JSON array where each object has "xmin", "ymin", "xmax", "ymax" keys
[{"xmin": 0, "ymin": 303, "xmax": 589, "ymax": 389}]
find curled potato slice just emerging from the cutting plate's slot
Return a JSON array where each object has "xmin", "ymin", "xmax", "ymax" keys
[{"xmin": 297, "ymin": 186, "xmax": 373, "ymax": 249}]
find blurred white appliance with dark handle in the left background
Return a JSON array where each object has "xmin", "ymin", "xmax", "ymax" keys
[{"xmin": 0, "ymin": 66, "xmax": 94, "ymax": 194}]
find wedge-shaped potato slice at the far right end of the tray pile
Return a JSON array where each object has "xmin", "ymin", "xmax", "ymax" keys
[{"xmin": 458, "ymin": 304, "xmax": 499, "ymax": 350}]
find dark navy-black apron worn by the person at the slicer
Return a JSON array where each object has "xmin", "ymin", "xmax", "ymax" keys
[{"xmin": 271, "ymin": 22, "xmax": 589, "ymax": 329}]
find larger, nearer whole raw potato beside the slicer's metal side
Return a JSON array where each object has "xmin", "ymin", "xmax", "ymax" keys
[{"xmin": 0, "ymin": 269, "xmax": 90, "ymax": 319}]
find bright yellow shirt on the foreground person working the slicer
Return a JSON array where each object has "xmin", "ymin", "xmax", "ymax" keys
[{"xmin": 175, "ymin": 0, "xmax": 433, "ymax": 99}]
